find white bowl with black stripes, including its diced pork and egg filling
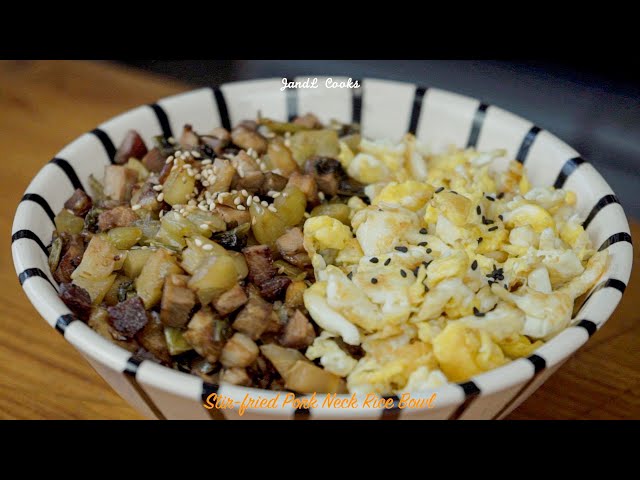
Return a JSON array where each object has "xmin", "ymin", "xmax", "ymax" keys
[{"xmin": 13, "ymin": 79, "xmax": 632, "ymax": 419}]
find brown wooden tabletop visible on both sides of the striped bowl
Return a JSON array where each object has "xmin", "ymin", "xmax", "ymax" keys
[{"xmin": 0, "ymin": 61, "xmax": 640, "ymax": 419}]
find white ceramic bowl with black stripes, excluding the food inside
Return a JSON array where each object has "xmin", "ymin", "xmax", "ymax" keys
[{"xmin": 12, "ymin": 78, "xmax": 632, "ymax": 419}]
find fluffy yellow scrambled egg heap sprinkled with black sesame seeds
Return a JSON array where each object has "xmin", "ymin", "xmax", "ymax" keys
[{"xmin": 304, "ymin": 135, "xmax": 607, "ymax": 394}]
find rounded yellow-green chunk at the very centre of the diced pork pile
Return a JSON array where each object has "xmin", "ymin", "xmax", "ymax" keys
[{"xmin": 188, "ymin": 255, "xmax": 238, "ymax": 305}]
